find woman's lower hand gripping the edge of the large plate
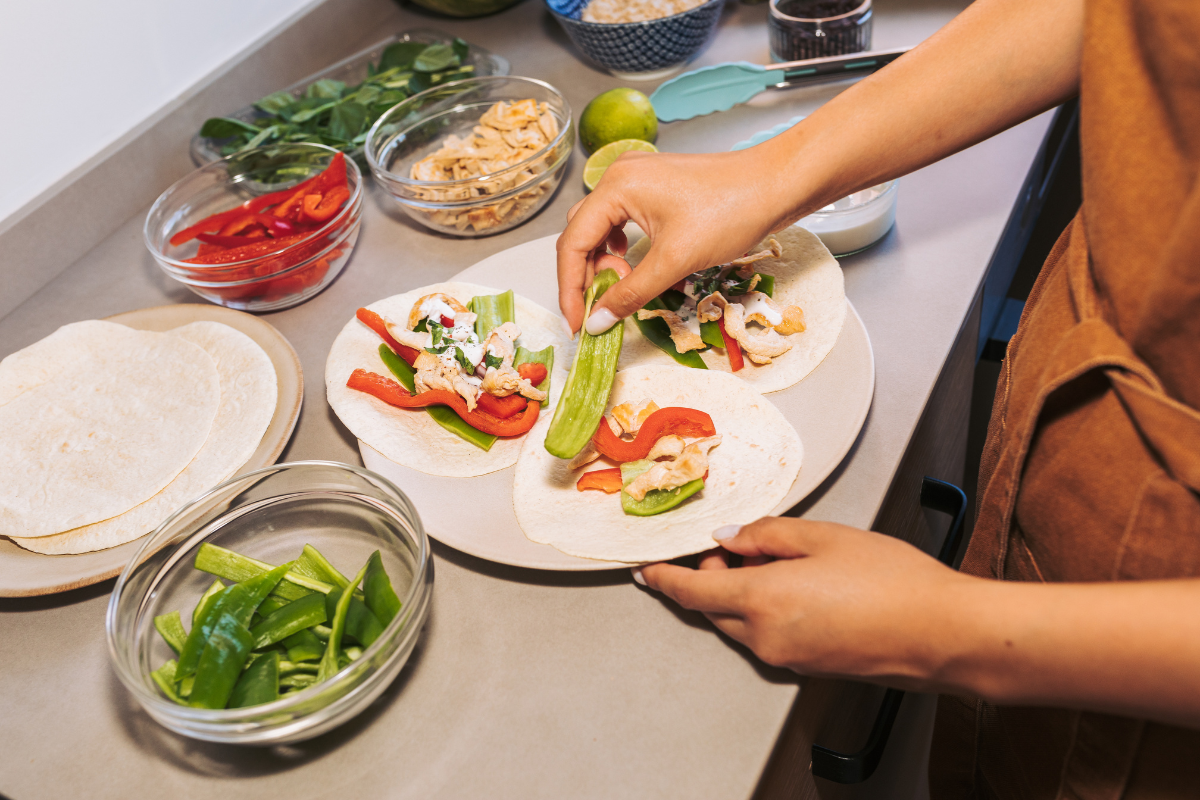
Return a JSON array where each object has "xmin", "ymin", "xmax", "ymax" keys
[{"xmin": 635, "ymin": 517, "xmax": 960, "ymax": 687}]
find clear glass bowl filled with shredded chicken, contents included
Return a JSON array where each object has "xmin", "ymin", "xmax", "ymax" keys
[{"xmin": 364, "ymin": 77, "xmax": 575, "ymax": 236}]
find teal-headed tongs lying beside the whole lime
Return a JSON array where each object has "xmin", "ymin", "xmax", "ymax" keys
[{"xmin": 650, "ymin": 47, "xmax": 910, "ymax": 122}]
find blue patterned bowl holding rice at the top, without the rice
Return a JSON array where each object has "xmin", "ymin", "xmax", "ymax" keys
[{"xmin": 546, "ymin": 0, "xmax": 725, "ymax": 80}]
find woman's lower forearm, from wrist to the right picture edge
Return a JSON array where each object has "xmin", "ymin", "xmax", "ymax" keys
[{"xmin": 918, "ymin": 579, "xmax": 1200, "ymax": 727}]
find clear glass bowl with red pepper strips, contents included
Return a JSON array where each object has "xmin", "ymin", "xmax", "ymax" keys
[{"xmin": 144, "ymin": 144, "xmax": 362, "ymax": 311}]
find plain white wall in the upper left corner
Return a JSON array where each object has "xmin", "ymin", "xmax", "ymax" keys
[{"xmin": 0, "ymin": 0, "xmax": 320, "ymax": 221}]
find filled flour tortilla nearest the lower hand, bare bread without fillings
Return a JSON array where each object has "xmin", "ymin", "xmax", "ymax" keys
[{"xmin": 512, "ymin": 365, "xmax": 804, "ymax": 564}]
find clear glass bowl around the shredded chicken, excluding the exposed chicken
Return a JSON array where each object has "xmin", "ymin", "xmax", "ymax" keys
[{"xmin": 364, "ymin": 77, "xmax": 575, "ymax": 236}]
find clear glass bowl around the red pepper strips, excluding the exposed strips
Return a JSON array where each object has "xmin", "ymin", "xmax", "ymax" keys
[{"xmin": 143, "ymin": 144, "xmax": 362, "ymax": 311}]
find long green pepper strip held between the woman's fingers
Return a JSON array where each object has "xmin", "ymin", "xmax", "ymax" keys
[{"xmin": 546, "ymin": 269, "xmax": 625, "ymax": 458}]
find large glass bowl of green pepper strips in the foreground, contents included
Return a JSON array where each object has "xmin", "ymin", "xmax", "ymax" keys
[{"xmin": 106, "ymin": 461, "xmax": 433, "ymax": 745}]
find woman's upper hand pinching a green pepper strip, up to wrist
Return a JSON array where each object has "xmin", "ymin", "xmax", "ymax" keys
[{"xmin": 558, "ymin": 148, "xmax": 787, "ymax": 333}]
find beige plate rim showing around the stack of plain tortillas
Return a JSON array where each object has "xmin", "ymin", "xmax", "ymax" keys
[{"xmin": 0, "ymin": 303, "xmax": 304, "ymax": 597}]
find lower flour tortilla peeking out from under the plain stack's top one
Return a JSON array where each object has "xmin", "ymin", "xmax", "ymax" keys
[{"xmin": 13, "ymin": 321, "xmax": 278, "ymax": 555}]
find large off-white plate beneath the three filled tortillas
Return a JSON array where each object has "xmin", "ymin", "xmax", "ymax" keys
[{"xmin": 359, "ymin": 235, "xmax": 875, "ymax": 571}]
